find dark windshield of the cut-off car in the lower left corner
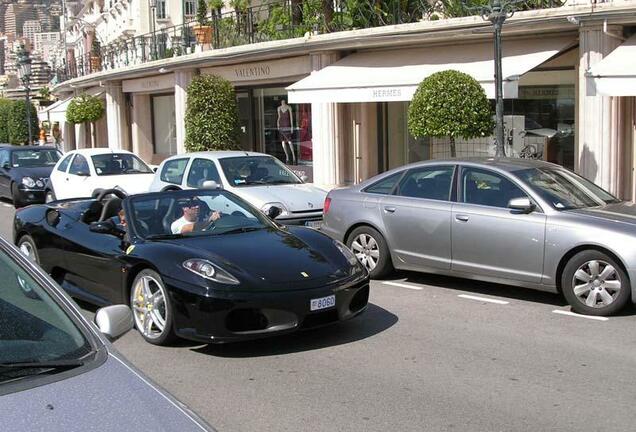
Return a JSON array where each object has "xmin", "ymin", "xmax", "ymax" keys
[{"xmin": 0, "ymin": 248, "xmax": 92, "ymax": 385}]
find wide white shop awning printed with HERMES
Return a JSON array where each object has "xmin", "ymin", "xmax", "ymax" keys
[{"xmin": 287, "ymin": 37, "xmax": 575, "ymax": 103}]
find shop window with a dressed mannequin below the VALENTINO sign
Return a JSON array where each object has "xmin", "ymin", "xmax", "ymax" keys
[{"xmin": 254, "ymin": 87, "xmax": 313, "ymax": 169}]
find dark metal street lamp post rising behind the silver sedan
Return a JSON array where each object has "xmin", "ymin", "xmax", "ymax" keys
[{"xmin": 468, "ymin": 0, "xmax": 526, "ymax": 157}]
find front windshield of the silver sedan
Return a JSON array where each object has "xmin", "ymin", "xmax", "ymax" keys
[{"xmin": 515, "ymin": 168, "xmax": 619, "ymax": 210}]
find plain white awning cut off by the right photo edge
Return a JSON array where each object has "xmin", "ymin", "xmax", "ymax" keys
[{"xmin": 587, "ymin": 35, "xmax": 636, "ymax": 96}]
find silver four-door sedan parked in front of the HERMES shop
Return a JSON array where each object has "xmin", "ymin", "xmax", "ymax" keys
[{"xmin": 322, "ymin": 158, "xmax": 636, "ymax": 315}]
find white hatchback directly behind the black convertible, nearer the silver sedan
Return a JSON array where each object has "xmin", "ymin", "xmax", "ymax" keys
[{"xmin": 150, "ymin": 151, "xmax": 327, "ymax": 227}]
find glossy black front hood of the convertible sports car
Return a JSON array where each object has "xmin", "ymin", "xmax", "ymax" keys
[{"xmin": 159, "ymin": 229, "xmax": 347, "ymax": 289}]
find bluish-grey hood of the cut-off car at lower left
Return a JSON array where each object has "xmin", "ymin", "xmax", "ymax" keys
[{"xmin": 0, "ymin": 356, "xmax": 209, "ymax": 432}]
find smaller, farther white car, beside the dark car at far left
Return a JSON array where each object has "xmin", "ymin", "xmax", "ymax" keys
[{"xmin": 45, "ymin": 148, "xmax": 154, "ymax": 202}]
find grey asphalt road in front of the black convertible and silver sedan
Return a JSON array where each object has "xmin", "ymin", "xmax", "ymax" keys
[{"xmin": 0, "ymin": 202, "xmax": 636, "ymax": 432}]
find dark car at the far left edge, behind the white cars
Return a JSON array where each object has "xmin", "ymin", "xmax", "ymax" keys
[{"xmin": 0, "ymin": 145, "xmax": 62, "ymax": 207}]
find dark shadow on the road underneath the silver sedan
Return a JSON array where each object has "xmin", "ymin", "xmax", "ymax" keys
[{"xmin": 392, "ymin": 271, "xmax": 636, "ymax": 317}]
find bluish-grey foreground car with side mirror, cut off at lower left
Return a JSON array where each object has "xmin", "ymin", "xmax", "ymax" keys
[{"xmin": 0, "ymin": 238, "xmax": 212, "ymax": 432}]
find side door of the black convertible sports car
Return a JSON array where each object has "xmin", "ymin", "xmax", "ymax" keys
[{"xmin": 60, "ymin": 209, "xmax": 127, "ymax": 304}]
